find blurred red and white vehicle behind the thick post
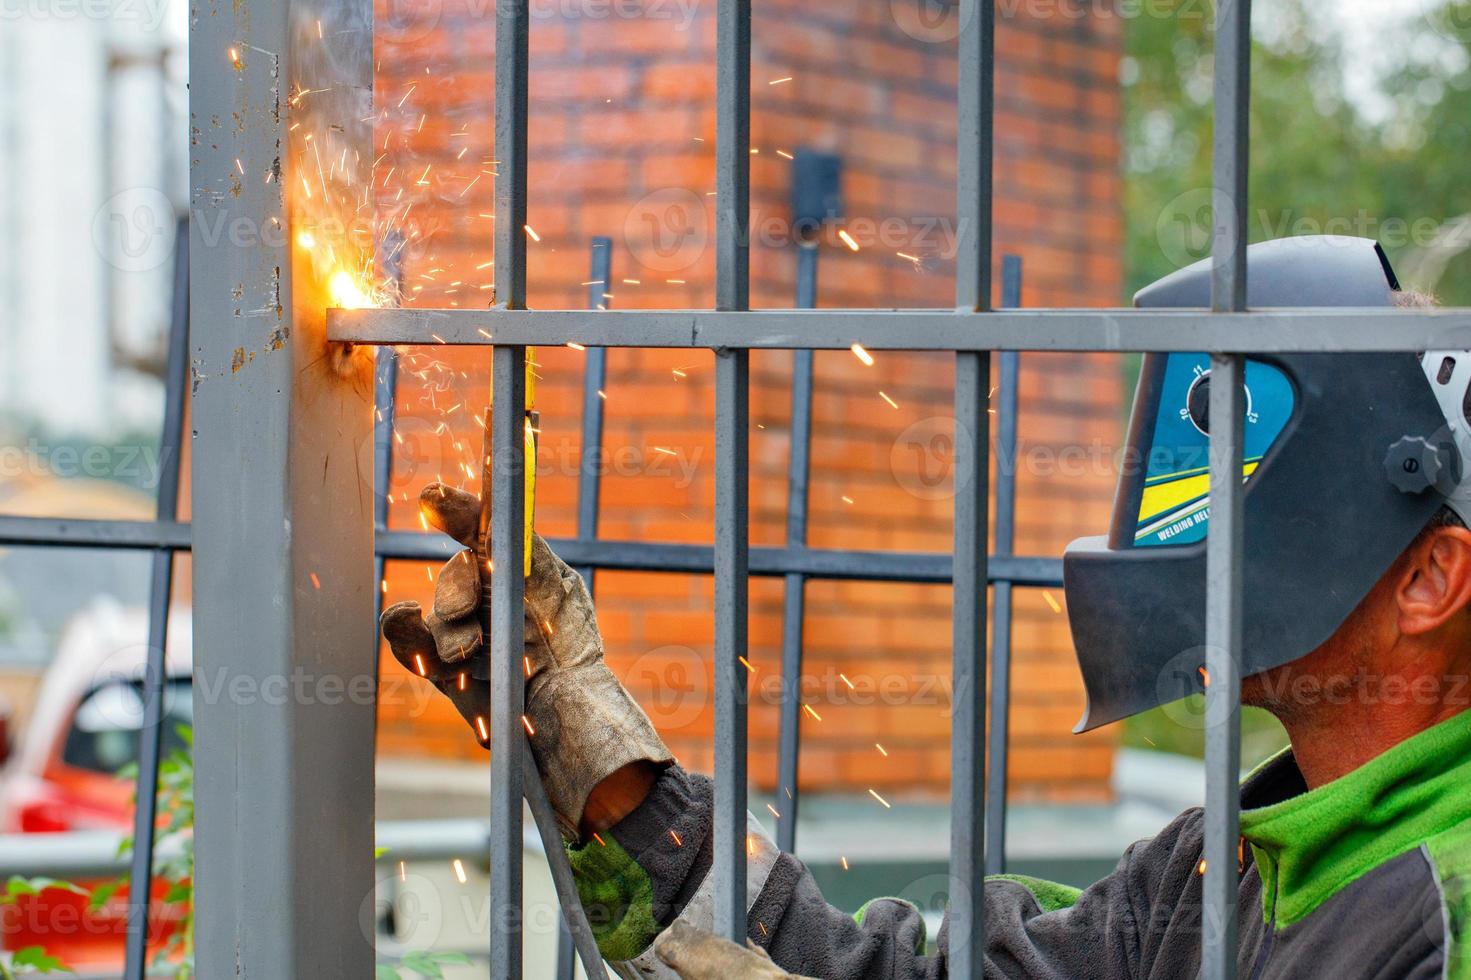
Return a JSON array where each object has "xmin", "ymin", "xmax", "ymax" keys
[{"xmin": 0, "ymin": 599, "xmax": 193, "ymax": 974}]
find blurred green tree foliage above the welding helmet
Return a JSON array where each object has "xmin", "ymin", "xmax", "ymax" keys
[{"xmin": 1122, "ymin": 0, "xmax": 1471, "ymax": 305}]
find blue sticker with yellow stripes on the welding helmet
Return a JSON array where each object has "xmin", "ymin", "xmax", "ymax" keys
[{"xmin": 1134, "ymin": 353, "xmax": 1294, "ymax": 547}]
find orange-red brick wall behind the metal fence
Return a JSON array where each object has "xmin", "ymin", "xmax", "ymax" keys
[{"xmin": 375, "ymin": 0, "xmax": 1121, "ymax": 799}]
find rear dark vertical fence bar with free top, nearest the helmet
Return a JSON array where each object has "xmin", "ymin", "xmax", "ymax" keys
[{"xmin": 986, "ymin": 255, "xmax": 1021, "ymax": 874}]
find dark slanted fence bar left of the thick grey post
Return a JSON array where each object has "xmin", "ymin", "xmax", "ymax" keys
[{"xmin": 124, "ymin": 218, "xmax": 188, "ymax": 980}]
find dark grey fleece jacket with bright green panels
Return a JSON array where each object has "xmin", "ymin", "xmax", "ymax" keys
[{"xmin": 571, "ymin": 712, "xmax": 1471, "ymax": 980}]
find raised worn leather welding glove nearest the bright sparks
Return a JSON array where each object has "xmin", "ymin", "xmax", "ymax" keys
[{"xmin": 381, "ymin": 483, "xmax": 674, "ymax": 840}]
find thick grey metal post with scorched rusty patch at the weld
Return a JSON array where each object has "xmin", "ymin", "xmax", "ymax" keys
[{"xmin": 190, "ymin": 0, "xmax": 375, "ymax": 979}]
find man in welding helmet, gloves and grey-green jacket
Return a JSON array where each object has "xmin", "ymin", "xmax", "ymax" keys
[{"xmin": 382, "ymin": 237, "xmax": 1471, "ymax": 980}]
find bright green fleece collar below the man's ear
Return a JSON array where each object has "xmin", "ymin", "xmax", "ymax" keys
[{"xmin": 1242, "ymin": 711, "xmax": 1471, "ymax": 928}]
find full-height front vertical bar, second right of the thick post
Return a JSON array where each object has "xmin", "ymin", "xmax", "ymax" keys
[{"xmin": 712, "ymin": 0, "xmax": 750, "ymax": 942}]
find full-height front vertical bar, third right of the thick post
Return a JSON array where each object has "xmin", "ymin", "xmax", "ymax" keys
[{"xmin": 950, "ymin": 0, "xmax": 996, "ymax": 980}]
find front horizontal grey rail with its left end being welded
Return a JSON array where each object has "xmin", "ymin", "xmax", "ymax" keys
[{"xmin": 327, "ymin": 308, "xmax": 1471, "ymax": 353}]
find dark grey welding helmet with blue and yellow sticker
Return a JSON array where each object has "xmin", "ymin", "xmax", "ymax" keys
[{"xmin": 1062, "ymin": 235, "xmax": 1471, "ymax": 731}]
